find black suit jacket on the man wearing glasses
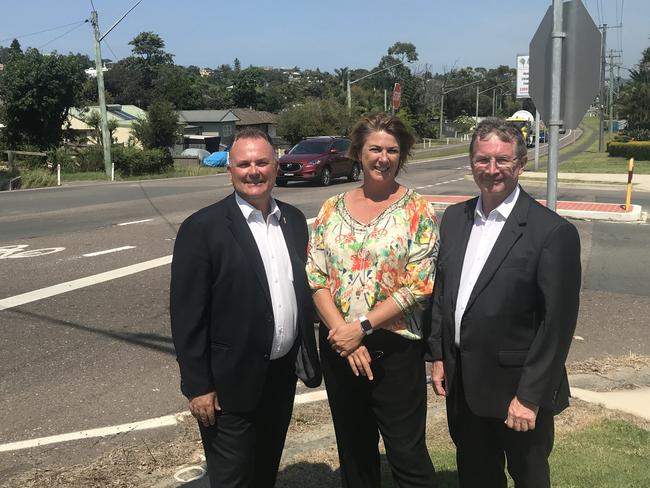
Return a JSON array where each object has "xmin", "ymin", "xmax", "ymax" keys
[{"xmin": 429, "ymin": 190, "xmax": 581, "ymax": 419}]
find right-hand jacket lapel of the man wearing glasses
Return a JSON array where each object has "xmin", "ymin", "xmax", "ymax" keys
[{"xmin": 465, "ymin": 189, "xmax": 530, "ymax": 312}]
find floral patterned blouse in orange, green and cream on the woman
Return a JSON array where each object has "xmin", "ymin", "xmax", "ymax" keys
[{"xmin": 307, "ymin": 190, "xmax": 439, "ymax": 340}]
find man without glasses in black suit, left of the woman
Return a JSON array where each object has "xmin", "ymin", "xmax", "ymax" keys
[{"xmin": 170, "ymin": 130, "xmax": 321, "ymax": 488}]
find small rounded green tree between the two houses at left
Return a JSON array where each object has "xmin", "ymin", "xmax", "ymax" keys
[{"xmin": 133, "ymin": 101, "xmax": 179, "ymax": 150}]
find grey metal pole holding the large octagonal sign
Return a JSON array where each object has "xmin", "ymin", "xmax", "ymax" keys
[{"xmin": 546, "ymin": 0, "xmax": 566, "ymax": 211}]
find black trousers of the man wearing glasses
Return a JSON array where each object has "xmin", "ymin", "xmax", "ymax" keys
[{"xmin": 447, "ymin": 357, "xmax": 554, "ymax": 488}]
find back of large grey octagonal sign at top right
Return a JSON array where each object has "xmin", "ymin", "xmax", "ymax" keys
[{"xmin": 529, "ymin": 0, "xmax": 601, "ymax": 129}]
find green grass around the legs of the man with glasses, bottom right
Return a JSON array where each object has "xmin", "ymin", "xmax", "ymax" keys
[{"xmin": 382, "ymin": 419, "xmax": 650, "ymax": 488}]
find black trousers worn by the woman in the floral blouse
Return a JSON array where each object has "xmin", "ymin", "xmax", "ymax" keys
[{"xmin": 320, "ymin": 326, "xmax": 435, "ymax": 488}]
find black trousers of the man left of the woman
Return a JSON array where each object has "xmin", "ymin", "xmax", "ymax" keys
[{"xmin": 199, "ymin": 354, "xmax": 296, "ymax": 488}]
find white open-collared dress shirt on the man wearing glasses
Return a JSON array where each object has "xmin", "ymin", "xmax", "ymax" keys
[{"xmin": 454, "ymin": 186, "xmax": 519, "ymax": 346}]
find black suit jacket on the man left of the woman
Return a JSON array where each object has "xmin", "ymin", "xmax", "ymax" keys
[{"xmin": 170, "ymin": 193, "xmax": 321, "ymax": 411}]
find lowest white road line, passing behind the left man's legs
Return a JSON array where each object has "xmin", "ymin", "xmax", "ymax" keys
[{"xmin": 0, "ymin": 390, "xmax": 327, "ymax": 452}]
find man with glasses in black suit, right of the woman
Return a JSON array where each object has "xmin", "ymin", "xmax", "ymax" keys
[{"xmin": 429, "ymin": 119, "xmax": 581, "ymax": 488}]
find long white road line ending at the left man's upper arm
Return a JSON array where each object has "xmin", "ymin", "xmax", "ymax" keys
[{"xmin": 0, "ymin": 254, "xmax": 172, "ymax": 310}]
